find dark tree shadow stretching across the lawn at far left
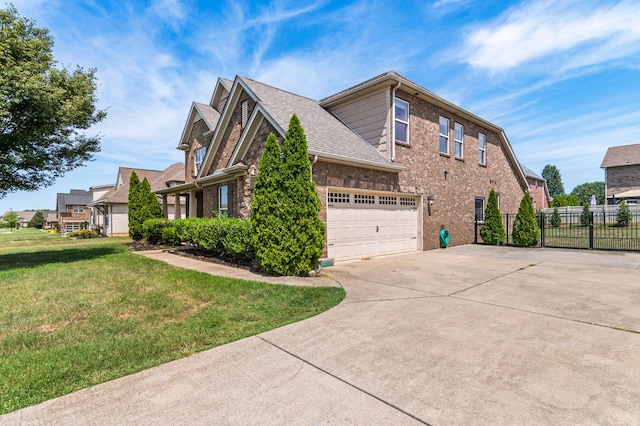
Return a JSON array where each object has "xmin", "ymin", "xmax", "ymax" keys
[{"xmin": 0, "ymin": 245, "xmax": 126, "ymax": 271}]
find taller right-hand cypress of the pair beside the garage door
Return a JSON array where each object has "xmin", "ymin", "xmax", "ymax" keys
[{"xmin": 281, "ymin": 114, "xmax": 326, "ymax": 275}]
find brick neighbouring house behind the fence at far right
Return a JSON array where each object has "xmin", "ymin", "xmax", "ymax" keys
[{"xmin": 600, "ymin": 144, "xmax": 640, "ymax": 204}]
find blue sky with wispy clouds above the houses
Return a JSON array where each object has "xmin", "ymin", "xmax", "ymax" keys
[{"xmin": 0, "ymin": 0, "xmax": 640, "ymax": 213}]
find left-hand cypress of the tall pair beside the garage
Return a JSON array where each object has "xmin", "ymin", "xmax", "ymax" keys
[{"xmin": 251, "ymin": 133, "xmax": 283, "ymax": 274}]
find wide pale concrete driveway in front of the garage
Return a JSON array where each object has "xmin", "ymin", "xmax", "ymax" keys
[{"xmin": 0, "ymin": 245, "xmax": 640, "ymax": 425}]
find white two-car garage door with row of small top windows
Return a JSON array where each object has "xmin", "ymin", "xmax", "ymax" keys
[{"xmin": 327, "ymin": 188, "xmax": 420, "ymax": 260}]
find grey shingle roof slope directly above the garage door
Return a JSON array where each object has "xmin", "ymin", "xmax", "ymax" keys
[{"xmin": 238, "ymin": 77, "xmax": 394, "ymax": 166}]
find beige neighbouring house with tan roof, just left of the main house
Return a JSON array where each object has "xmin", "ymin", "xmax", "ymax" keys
[{"xmin": 89, "ymin": 163, "xmax": 185, "ymax": 236}]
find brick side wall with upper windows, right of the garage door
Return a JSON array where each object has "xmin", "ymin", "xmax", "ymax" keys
[{"xmin": 396, "ymin": 90, "xmax": 526, "ymax": 250}]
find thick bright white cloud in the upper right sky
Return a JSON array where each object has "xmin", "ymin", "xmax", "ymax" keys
[{"xmin": 463, "ymin": 0, "xmax": 640, "ymax": 72}]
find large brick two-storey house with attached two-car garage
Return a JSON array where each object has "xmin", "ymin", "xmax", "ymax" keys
[{"xmin": 157, "ymin": 71, "xmax": 528, "ymax": 259}]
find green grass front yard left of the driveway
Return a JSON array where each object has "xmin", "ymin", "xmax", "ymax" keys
[{"xmin": 0, "ymin": 230, "xmax": 345, "ymax": 414}]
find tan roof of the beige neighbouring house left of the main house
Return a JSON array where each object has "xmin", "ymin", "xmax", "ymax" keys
[{"xmin": 92, "ymin": 163, "xmax": 184, "ymax": 204}]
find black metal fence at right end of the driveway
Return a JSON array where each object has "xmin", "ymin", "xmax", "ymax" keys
[{"xmin": 475, "ymin": 210, "xmax": 640, "ymax": 251}]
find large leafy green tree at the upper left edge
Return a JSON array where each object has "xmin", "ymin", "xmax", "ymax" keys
[{"xmin": 0, "ymin": 6, "xmax": 106, "ymax": 198}]
